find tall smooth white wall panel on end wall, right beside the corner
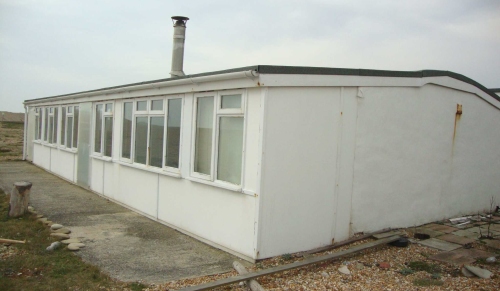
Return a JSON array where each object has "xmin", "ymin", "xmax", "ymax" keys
[{"xmin": 259, "ymin": 87, "xmax": 340, "ymax": 258}]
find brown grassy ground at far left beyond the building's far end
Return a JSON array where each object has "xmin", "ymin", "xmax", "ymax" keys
[{"xmin": 0, "ymin": 121, "xmax": 24, "ymax": 161}]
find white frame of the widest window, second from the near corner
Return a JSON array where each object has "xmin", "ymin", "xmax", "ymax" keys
[{"xmin": 119, "ymin": 94, "xmax": 184, "ymax": 176}]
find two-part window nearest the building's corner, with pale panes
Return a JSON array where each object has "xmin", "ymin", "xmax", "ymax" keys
[{"xmin": 192, "ymin": 92, "xmax": 244, "ymax": 185}]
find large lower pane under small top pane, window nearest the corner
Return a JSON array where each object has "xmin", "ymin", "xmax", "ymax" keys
[{"xmin": 217, "ymin": 117, "xmax": 243, "ymax": 185}]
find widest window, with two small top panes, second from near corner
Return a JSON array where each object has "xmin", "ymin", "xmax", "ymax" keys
[{"xmin": 121, "ymin": 98, "xmax": 182, "ymax": 169}]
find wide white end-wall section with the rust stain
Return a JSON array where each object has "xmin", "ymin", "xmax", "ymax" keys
[{"xmin": 352, "ymin": 85, "xmax": 500, "ymax": 231}]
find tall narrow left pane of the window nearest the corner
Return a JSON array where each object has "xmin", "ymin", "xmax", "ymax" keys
[{"xmin": 194, "ymin": 97, "xmax": 214, "ymax": 175}]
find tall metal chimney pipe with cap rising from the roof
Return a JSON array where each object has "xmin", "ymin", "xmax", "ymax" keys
[{"xmin": 170, "ymin": 16, "xmax": 189, "ymax": 78}]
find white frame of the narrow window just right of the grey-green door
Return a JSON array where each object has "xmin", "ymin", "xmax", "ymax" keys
[{"xmin": 91, "ymin": 100, "xmax": 115, "ymax": 160}]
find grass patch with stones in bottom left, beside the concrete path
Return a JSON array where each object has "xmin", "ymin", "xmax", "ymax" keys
[{"xmin": 0, "ymin": 189, "xmax": 145, "ymax": 291}]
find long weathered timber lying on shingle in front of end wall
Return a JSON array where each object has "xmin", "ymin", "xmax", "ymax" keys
[{"xmin": 179, "ymin": 235, "xmax": 401, "ymax": 291}]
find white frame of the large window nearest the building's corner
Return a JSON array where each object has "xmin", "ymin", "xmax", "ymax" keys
[{"xmin": 189, "ymin": 89, "xmax": 247, "ymax": 191}]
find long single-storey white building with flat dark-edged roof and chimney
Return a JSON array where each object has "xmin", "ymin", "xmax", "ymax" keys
[{"xmin": 24, "ymin": 17, "xmax": 500, "ymax": 261}]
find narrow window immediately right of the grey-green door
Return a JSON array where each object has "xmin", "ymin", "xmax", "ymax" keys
[{"xmin": 94, "ymin": 103, "xmax": 113, "ymax": 157}]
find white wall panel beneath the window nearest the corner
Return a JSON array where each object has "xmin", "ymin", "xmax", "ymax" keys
[{"xmin": 158, "ymin": 175, "xmax": 256, "ymax": 258}]
